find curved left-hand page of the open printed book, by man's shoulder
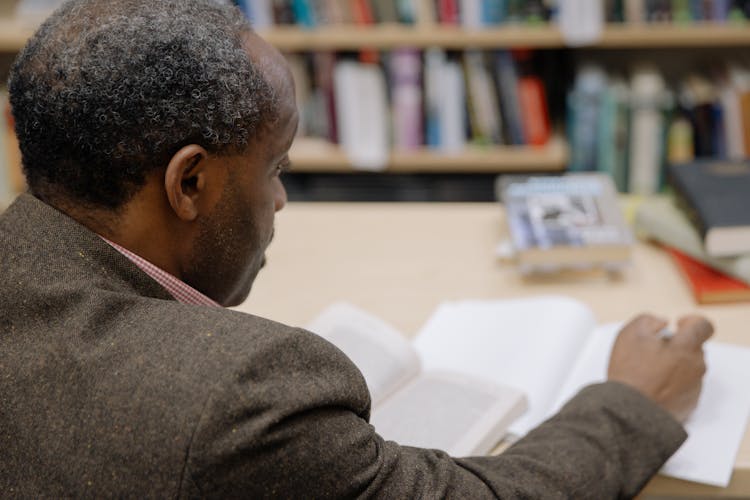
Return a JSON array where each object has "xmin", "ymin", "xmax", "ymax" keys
[{"xmin": 307, "ymin": 302, "xmax": 421, "ymax": 406}]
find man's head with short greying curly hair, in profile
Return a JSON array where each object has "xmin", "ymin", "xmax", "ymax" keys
[{"xmin": 9, "ymin": 0, "xmax": 297, "ymax": 305}]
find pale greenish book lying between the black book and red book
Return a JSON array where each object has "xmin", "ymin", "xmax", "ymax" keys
[{"xmin": 634, "ymin": 196, "xmax": 750, "ymax": 285}]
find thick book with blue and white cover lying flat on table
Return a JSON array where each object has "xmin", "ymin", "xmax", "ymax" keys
[{"xmin": 496, "ymin": 173, "xmax": 633, "ymax": 273}]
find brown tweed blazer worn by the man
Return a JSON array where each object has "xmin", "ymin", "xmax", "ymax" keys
[{"xmin": 0, "ymin": 195, "xmax": 685, "ymax": 499}]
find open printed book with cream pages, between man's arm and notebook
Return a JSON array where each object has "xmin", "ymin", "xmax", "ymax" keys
[{"xmin": 309, "ymin": 303, "xmax": 526, "ymax": 456}]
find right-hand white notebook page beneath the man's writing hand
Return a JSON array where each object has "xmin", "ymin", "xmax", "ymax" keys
[{"xmin": 556, "ymin": 324, "xmax": 750, "ymax": 487}]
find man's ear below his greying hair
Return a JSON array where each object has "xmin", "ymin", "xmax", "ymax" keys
[{"xmin": 164, "ymin": 144, "xmax": 209, "ymax": 221}]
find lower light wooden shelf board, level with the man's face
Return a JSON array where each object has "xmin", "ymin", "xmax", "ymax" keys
[{"xmin": 289, "ymin": 138, "xmax": 569, "ymax": 173}]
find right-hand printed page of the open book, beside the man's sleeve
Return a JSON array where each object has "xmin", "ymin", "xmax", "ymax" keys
[{"xmin": 370, "ymin": 372, "xmax": 525, "ymax": 457}]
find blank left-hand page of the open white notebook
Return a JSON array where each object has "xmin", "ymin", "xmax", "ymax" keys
[{"xmin": 414, "ymin": 296, "xmax": 595, "ymax": 435}]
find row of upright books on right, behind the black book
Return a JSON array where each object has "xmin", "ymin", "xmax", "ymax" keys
[{"xmin": 567, "ymin": 63, "xmax": 750, "ymax": 195}]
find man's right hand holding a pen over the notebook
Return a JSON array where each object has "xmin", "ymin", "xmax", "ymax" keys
[{"xmin": 607, "ymin": 314, "xmax": 714, "ymax": 422}]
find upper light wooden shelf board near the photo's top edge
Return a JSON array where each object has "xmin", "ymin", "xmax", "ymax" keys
[{"xmin": 0, "ymin": 19, "xmax": 750, "ymax": 52}]
